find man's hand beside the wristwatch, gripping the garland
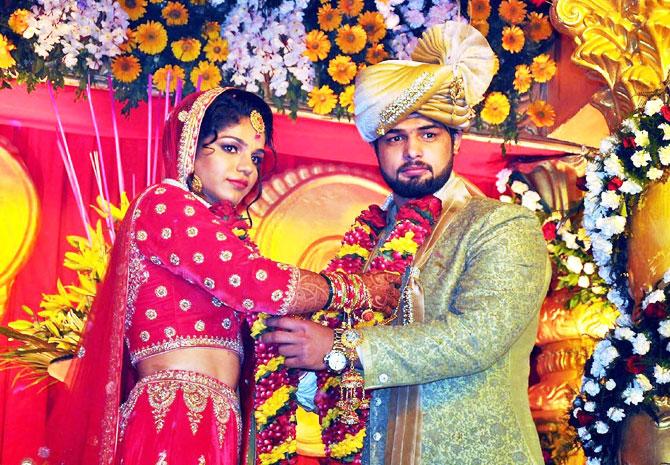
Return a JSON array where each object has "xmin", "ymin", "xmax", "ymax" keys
[{"xmin": 261, "ymin": 317, "xmax": 333, "ymax": 370}]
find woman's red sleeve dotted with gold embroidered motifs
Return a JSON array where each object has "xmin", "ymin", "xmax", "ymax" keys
[{"xmin": 135, "ymin": 185, "xmax": 299, "ymax": 315}]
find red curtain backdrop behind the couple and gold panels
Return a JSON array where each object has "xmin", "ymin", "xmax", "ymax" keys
[{"xmin": 0, "ymin": 86, "xmax": 560, "ymax": 465}]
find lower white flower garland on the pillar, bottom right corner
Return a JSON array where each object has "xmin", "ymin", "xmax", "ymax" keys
[{"xmin": 570, "ymin": 270, "xmax": 670, "ymax": 465}]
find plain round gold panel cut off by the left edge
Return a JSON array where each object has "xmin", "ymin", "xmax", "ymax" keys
[{"xmin": 0, "ymin": 138, "xmax": 39, "ymax": 318}]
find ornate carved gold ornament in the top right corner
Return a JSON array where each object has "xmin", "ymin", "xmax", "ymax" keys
[{"xmin": 552, "ymin": 0, "xmax": 670, "ymax": 129}]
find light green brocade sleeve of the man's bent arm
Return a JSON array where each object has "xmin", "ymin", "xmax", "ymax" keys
[{"xmin": 359, "ymin": 205, "xmax": 551, "ymax": 388}]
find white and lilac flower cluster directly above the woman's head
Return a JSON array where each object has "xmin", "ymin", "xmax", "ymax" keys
[{"xmin": 222, "ymin": 0, "xmax": 314, "ymax": 99}]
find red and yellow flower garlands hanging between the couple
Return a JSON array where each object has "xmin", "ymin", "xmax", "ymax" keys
[{"xmin": 250, "ymin": 195, "xmax": 442, "ymax": 465}]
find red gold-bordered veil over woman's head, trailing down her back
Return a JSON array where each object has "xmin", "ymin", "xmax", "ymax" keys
[{"xmin": 47, "ymin": 88, "xmax": 231, "ymax": 465}]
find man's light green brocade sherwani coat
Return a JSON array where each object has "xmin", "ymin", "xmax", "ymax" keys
[{"xmin": 359, "ymin": 178, "xmax": 551, "ymax": 465}]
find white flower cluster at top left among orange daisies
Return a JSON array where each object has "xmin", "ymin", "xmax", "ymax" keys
[{"xmin": 23, "ymin": 0, "xmax": 128, "ymax": 70}]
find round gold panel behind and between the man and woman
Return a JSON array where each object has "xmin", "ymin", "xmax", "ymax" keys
[{"xmin": 251, "ymin": 165, "xmax": 389, "ymax": 271}]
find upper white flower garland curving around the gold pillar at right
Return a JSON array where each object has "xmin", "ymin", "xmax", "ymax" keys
[{"xmin": 584, "ymin": 93, "xmax": 670, "ymax": 313}]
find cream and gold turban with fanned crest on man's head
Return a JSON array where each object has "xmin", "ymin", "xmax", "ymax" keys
[{"xmin": 354, "ymin": 21, "xmax": 495, "ymax": 142}]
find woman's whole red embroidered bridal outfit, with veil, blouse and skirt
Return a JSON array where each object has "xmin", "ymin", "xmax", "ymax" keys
[{"xmin": 48, "ymin": 89, "xmax": 298, "ymax": 465}]
